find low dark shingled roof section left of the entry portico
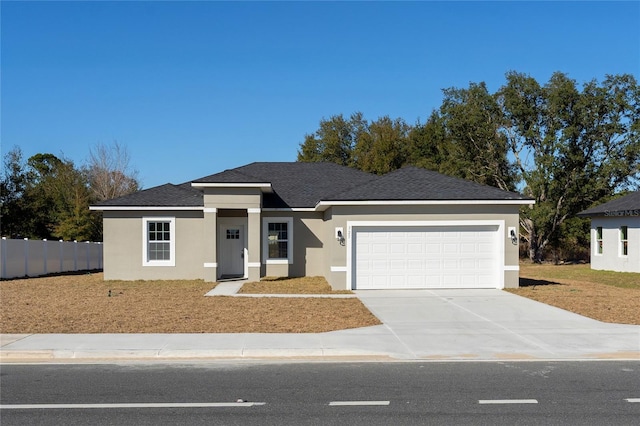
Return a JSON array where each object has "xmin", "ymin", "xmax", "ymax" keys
[{"xmin": 92, "ymin": 182, "xmax": 204, "ymax": 210}]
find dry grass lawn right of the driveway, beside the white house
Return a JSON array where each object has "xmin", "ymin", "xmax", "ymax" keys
[{"xmin": 507, "ymin": 264, "xmax": 640, "ymax": 325}]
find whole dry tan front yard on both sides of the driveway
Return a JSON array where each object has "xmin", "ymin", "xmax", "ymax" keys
[{"xmin": 0, "ymin": 264, "xmax": 640, "ymax": 333}]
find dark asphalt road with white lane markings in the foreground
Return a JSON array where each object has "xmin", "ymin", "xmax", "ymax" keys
[{"xmin": 0, "ymin": 361, "xmax": 640, "ymax": 426}]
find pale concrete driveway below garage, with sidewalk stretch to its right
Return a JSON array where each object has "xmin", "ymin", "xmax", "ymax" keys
[{"xmin": 356, "ymin": 290, "xmax": 640, "ymax": 359}]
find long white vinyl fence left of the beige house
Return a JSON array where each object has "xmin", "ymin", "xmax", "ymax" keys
[{"xmin": 0, "ymin": 237, "xmax": 103, "ymax": 278}]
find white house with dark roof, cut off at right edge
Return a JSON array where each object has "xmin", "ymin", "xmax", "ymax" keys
[{"xmin": 578, "ymin": 191, "xmax": 640, "ymax": 272}]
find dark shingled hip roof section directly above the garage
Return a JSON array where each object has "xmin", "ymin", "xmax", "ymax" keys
[{"xmin": 324, "ymin": 166, "xmax": 528, "ymax": 201}]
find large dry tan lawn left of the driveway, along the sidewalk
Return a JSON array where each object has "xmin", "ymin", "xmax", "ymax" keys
[{"xmin": 0, "ymin": 273, "xmax": 380, "ymax": 333}]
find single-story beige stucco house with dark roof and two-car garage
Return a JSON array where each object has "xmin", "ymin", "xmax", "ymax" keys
[{"xmin": 91, "ymin": 162, "xmax": 534, "ymax": 289}]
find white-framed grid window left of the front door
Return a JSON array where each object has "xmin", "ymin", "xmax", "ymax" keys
[{"xmin": 142, "ymin": 217, "xmax": 175, "ymax": 266}]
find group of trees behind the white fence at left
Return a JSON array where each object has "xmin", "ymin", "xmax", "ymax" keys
[{"xmin": 0, "ymin": 143, "xmax": 140, "ymax": 241}]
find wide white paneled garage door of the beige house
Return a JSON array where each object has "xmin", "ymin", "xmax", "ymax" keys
[{"xmin": 352, "ymin": 226, "xmax": 499, "ymax": 289}]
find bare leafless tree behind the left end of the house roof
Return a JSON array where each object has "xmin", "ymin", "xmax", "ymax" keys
[{"xmin": 86, "ymin": 142, "xmax": 140, "ymax": 202}]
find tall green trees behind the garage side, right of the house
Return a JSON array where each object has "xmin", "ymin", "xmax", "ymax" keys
[{"xmin": 298, "ymin": 71, "xmax": 640, "ymax": 262}]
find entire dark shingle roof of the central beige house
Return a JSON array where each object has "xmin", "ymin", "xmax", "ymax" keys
[{"xmin": 96, "ymin": 162, "xmax": 528, "ymax": 208}]
